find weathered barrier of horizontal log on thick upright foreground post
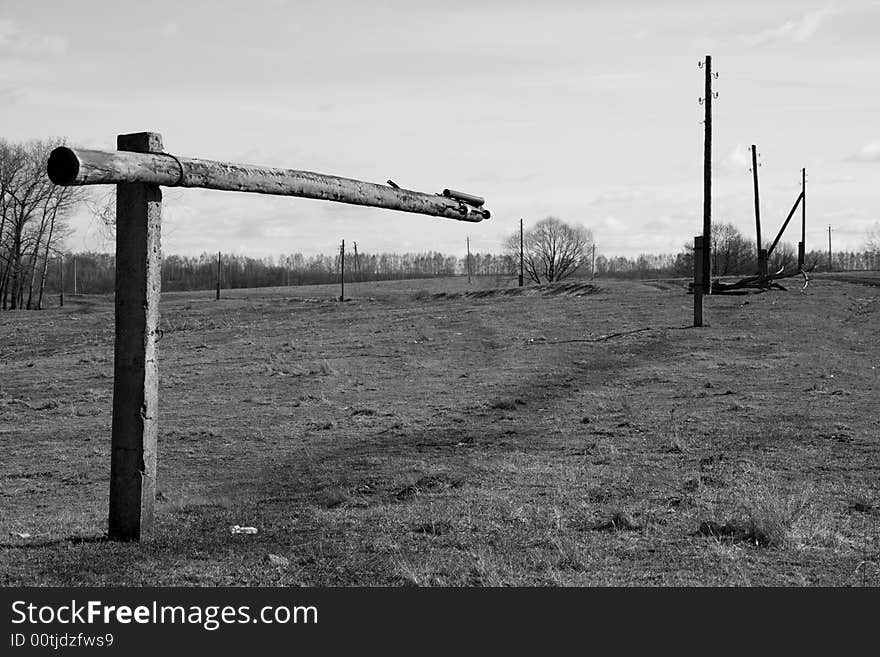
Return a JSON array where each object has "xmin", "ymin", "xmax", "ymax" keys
[{"xmin": 47, "ymin": 132, "xmax": 490, "ymax": 541}]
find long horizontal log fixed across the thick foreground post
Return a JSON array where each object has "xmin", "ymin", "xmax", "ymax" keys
[{"xmin": 46, "ymin": 146, "xmax": 490, "ymax": 223}]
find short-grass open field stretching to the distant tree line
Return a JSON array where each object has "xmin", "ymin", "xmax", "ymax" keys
[{"xmin": 0, "ymin": 273, "xmax": 880, "ymax": 586}]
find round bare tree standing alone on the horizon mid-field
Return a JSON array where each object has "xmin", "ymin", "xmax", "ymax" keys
[{"xmin": 505, "ymin": 217, "xmax": 593, "ymax": 284}]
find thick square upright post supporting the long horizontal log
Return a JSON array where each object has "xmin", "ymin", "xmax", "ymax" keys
[{"xmin": 108, "ymin": 132, "xmax": 162, "ymax": 541}]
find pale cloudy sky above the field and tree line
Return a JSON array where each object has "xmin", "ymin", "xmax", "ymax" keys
[{"xmin": 0, "ymin": 0, "xmax": 880, "ymax": 256}]
